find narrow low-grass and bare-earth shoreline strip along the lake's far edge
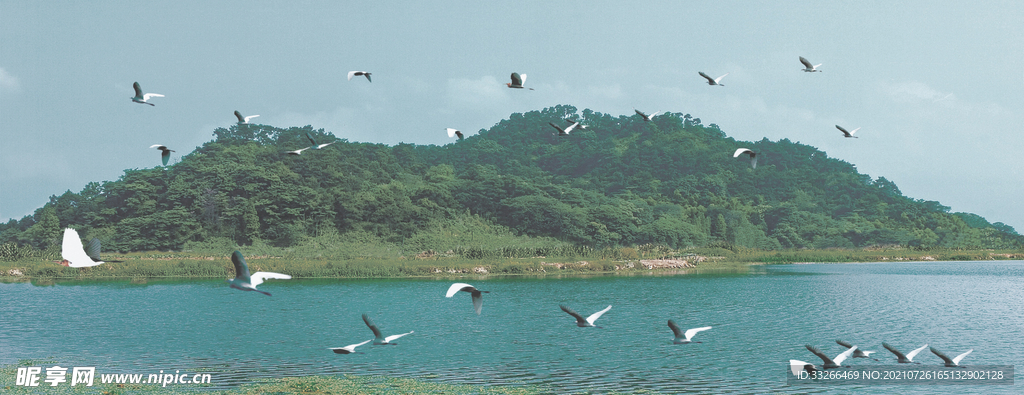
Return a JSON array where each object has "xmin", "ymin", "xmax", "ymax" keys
[{"xmin": 0, "ymin": 250, "xmax": 1024, "ymax": 283}]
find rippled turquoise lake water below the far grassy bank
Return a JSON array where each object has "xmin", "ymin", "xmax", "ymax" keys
[{"xmin": 0, "ymin": 261, "xmax": 1024, "ymax": 393}]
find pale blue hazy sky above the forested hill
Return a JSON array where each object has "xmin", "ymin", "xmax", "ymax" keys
[{"xmin": 0, "ymin": 0, "xmax": 1024, "ymax": 232}]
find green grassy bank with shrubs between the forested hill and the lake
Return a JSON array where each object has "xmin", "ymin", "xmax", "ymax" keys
[{"xmin": 0, "ymin": 240, "xmax": 1024, "ymax": 280}]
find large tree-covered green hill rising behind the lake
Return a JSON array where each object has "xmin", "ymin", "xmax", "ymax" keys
[{"xmin": 0, "ymin": 105, "xmax": 1024, "ymax": 251}]
